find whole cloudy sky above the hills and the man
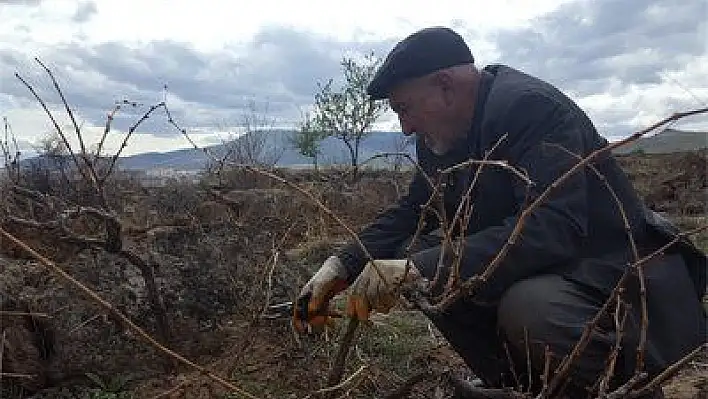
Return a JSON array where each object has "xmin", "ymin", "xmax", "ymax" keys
[{"xmin": 0, "ymin": 0, "xmax": 708, "ymax": 155}]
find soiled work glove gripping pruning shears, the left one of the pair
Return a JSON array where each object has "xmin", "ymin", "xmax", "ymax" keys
[{"xmin": 293, "ymin": 256, "xmax": 348, "ymax": 332}]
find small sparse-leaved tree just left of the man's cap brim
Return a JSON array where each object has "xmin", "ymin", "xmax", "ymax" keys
[{"xmin": 313, "ymin": 54, "xmax": 386, "ymax": 175}]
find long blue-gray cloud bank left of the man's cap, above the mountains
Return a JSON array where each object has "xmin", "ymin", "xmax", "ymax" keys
[{"xmin": 0, "ymin": 27, "xmax": 392, "ymax": 137}]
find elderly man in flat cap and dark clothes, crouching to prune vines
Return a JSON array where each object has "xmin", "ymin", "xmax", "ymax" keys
[{"xmin": 294, "ymin": 27, "xmax": 706, "ymax": 397}]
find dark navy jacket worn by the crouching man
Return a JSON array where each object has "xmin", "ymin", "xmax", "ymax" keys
[{"xmin": 339, "ymin": 65, "xmax": 706, "ymax": 372}]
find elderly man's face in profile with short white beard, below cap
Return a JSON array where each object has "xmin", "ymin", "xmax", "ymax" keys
[{"xmin": 388, "ymin": 77, "xmax": 462, "ymax": 155}]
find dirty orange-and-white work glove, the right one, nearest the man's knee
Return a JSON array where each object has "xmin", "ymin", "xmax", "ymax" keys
[{"xmin": 346, "ymin": 259, "xmax": 423, "ymax": 321}]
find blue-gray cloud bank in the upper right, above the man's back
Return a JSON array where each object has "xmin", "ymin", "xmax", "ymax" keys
[{"xmin": 494, "ymin": 0, "xmax": 708, "ymax": 95}]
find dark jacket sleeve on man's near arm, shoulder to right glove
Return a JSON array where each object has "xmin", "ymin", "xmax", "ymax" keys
[{"xmin": 413, "ymin": 92, "xmax": 592, "ymax": 302}]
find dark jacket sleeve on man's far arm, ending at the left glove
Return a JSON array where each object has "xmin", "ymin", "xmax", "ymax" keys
[{"xmin": 336, "ymin": 143, "xmax": 437, "ymax": 283}]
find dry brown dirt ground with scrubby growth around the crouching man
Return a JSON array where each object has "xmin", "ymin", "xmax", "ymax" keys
[{"xmin": 0, "ymin": 152, "xmax": 708, "ymax": 399}]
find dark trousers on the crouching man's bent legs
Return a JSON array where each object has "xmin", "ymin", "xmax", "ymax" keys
[{"xmin": 399, "ymin": 236, "xmax": 678, "ymax": 398}]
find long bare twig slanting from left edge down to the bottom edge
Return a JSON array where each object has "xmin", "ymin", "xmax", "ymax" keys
[{"xmin": 0, "ymin": 227, "xmax": 257, "ymax": 399}]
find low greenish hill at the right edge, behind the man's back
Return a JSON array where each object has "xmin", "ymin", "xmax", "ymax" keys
[{"xmin": 615, "ymin": 129, "xmax": 708, "ymax": 154}]
